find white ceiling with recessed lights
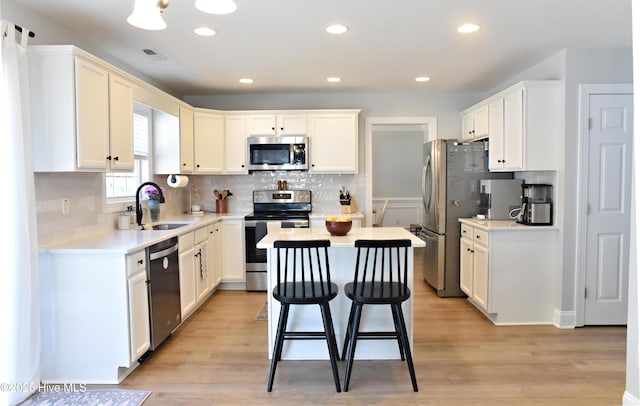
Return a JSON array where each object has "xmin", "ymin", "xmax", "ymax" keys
[{"xmin": 15, "ymin": 0, "xmax": 631, "ymax": 95}]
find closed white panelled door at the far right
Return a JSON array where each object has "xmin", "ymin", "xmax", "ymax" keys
[{"xmin": 584, "ymin": 94, "xmax": 633, "ymax": 325}]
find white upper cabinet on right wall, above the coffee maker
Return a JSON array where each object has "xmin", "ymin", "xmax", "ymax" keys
[{"xmin": 489, "ymin": 81, "xmax": 563, "ymax": 171}]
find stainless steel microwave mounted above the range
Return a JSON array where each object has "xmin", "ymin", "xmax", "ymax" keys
[{"xmin": 247, "ymin": 135, "xmax": 309, "ymax": 171}]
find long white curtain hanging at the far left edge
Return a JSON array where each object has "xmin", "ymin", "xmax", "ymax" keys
[{"xmin": 0, "ymin": 21, "xmax": 41, "ymax": 405}]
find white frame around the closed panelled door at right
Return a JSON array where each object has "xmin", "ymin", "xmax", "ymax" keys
[{"xmin": 575, "ymin": 83, "xmax": 635, "ymax": 327}]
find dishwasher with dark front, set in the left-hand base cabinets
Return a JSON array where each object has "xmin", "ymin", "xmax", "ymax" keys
[{"xmin": 147, "ymin": 237, "xmax": 181, "ymax": 351}]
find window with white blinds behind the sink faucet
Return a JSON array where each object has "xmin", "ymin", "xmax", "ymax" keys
[{"xmin": 104, "ymin": 106, "xmax": 151, "ymax": 211}]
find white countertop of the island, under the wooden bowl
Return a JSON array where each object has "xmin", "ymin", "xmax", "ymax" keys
[{"xmin": 256, "ymin": 227, "xmax": 426, "ymax": 248}]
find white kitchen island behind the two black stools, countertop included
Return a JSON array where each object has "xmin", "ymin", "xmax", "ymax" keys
[{"xmin": 257, "ymin": 227, "xmax": 425, "ymax": 359}]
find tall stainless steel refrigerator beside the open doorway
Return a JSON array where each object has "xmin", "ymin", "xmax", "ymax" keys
[{"xmin": 421, "ymin": 140, "xmax": 513, "ymax": 297}]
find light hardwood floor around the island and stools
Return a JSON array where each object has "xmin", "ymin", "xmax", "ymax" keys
[{"xmin": 119, "ymin": 251, "xmax": 626, "ymax": 406}]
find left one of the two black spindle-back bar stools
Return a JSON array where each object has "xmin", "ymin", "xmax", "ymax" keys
[{"xmin": 267, "ymin": 240, "xmax": 340, "ymax": 392}]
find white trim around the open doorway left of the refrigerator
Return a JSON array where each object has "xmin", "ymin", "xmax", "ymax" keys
[{"xmin": 364, "ymin": 116, "xmax": 438, "ymax": 227}]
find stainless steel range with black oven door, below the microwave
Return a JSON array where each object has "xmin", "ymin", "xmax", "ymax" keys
[{"xmin": 244, "ymin": 190, "xmax": 311, "ymax": 291}]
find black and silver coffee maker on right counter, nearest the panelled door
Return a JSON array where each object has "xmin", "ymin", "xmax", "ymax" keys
[{"xmin": 518, "ymin": 183, "xmax": 553, "ymax": 226}]
